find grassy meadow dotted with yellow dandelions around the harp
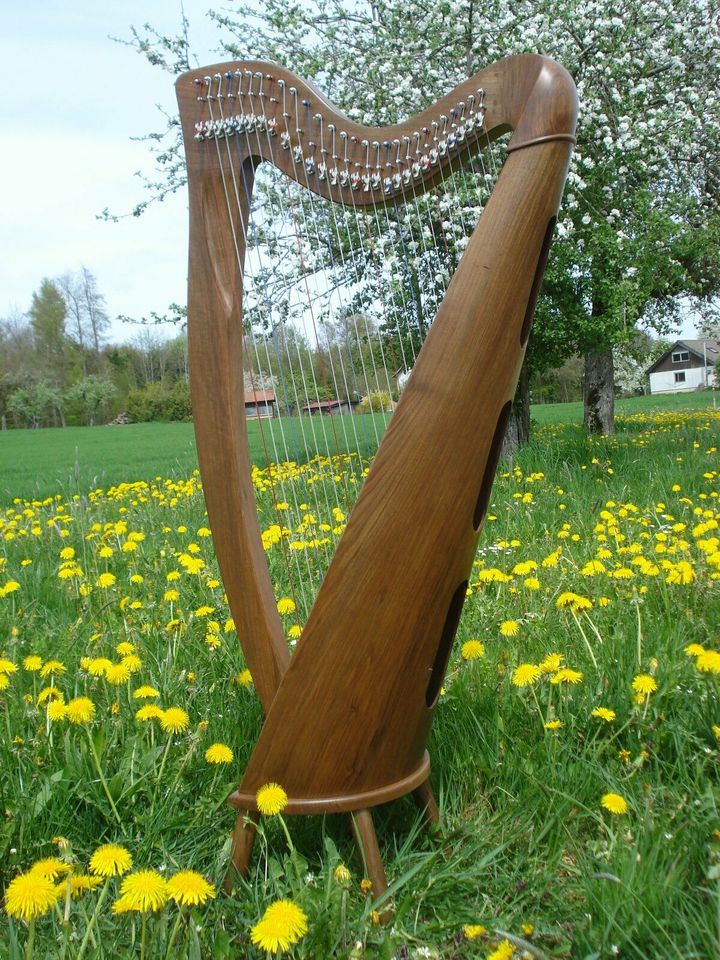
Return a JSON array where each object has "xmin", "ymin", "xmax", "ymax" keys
[{"xmin": 0, "ymin": 395, "xmax": 720, "ymax": 960}]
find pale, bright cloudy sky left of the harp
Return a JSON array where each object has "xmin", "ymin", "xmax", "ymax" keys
[{"xmin": 0, "ymin": 0, "xmax": 695, "ymax": 342}]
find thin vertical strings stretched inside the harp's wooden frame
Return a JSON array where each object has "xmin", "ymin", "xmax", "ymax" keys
[{"xmin": 208, "ymin": 71, "xmax": 496, "ymax": 619}]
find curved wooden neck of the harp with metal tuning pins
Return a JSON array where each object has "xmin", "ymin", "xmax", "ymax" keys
[{"xmin": 177, "ymin": 54, "xmax": 577, "ymax": 206}]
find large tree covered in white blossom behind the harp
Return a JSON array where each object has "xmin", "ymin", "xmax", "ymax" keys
[{"xmin": 124, "ymin": 0, "xmax": 720, "ymax": 438}]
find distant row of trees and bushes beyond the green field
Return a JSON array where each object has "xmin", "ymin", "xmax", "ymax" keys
[{"xmin": 0, "ymin": 267, "xmax": 666, "ymax": 429}]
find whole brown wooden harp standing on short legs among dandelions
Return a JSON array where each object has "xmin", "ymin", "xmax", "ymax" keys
[{"xmin": 177, "ymin": 55, "xmax": 577, "ymax": 895}]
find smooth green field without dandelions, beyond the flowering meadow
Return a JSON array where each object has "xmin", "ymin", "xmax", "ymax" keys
[{"xmin": 0, "ymin": 392, "xmax": 716, "ymax": 504}]
